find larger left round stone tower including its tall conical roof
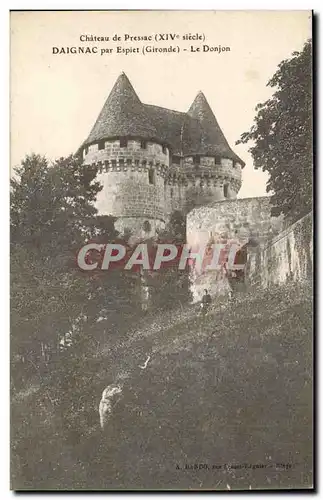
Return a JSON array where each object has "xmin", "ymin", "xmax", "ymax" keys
[{"xmin": 82, "ymin": 73, "xmax": 170, "ymax": 238}]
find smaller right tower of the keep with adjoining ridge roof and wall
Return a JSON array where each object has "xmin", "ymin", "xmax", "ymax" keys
[{"xmin": 156, "ymin": 92, "xmax": 245, "ymax": 214}]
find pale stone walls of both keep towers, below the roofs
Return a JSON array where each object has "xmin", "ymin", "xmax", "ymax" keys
[{"xmin": 83, "ymin": 138, "xmax": 241, "ymax": 237}]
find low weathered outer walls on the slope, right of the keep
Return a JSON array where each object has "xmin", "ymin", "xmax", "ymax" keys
[{"xmin": 187, "ymin": 197, "xmax": 313, "ymax": 301}]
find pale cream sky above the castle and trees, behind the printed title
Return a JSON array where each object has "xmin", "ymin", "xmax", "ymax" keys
[{"xmin": 10, "ymin": 11, "xmax": 311, "ymax": 198}]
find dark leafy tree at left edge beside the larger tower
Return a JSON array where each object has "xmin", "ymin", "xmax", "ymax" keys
[{"xmin": 10, "ymin": 154, "xmax": 101, "ymax": 359}]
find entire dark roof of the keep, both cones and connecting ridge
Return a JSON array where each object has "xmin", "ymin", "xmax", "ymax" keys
[{"xmin": 82, "ymin": 73, "xmax": 245, "ymax": 166}]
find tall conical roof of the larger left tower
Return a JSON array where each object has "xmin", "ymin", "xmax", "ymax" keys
[{"xmin": 83, "ymin": 73, "xmax": 157, "ymax": 145}]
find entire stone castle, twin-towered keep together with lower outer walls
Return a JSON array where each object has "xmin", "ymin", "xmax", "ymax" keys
[{"xmin": 79, "ymin": 73, "xmax": 313, "ymax": 300}]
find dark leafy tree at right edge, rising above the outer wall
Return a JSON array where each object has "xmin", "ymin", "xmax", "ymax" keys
[{"xmin": 237, "ymin": 41, "xmax": 313, "ymax": 221}]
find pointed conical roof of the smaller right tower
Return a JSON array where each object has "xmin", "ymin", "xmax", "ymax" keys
[{"xmin": 188, "ymin": 91, "xmax": 243, "ymax": 163}]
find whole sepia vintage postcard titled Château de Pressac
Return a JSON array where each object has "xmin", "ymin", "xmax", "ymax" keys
[{"xmin": 10, "ymin": 10, "xmax": 314, "ymax": 491}]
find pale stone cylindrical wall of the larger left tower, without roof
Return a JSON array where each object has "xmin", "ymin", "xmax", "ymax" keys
[{"xmin": 84, "ymin": 140, "xmax": 169, "ymax": 237}]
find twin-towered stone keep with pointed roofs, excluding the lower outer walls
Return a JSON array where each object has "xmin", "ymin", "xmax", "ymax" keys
[{"xmin": 81, "ymin": 73, "xmax": 245, "ymax": 238}]
